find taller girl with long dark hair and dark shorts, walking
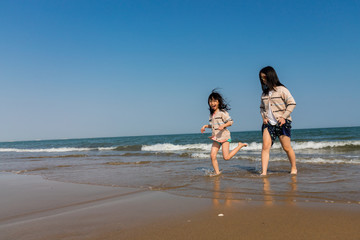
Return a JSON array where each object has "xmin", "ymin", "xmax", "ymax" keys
[{"xmin": 259, "ymin": 66, "xmax": 297, "ymax": 176}]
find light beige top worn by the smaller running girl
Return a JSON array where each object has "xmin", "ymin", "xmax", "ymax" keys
[{"xmin": 209, "ymin": 110, "xmax": 233, "ymax": 142}]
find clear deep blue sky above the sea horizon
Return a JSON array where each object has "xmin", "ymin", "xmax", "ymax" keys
[{"xmin": 0, "ymin": 0, "xmax": 360, "ymax": 141}]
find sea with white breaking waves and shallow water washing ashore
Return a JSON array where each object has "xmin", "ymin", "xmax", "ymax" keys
[{"xmin": 0, "ymin": 127, "xmax": 360, "ymax": 204}]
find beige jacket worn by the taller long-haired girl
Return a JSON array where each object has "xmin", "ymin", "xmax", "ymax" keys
[{"xmin": 260, "ymin": 86, "xmax": 296, "ymax": 121}]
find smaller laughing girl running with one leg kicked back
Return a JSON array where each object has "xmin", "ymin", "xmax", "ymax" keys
[{"xmin": 201, "ymin": 89, "xmax": 247, "ymax": 176}]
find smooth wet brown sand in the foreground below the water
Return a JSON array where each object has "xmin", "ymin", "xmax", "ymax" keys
[{"xmin": 0, "ymin": 174, "xmax": 360, "ymax": 240}]
